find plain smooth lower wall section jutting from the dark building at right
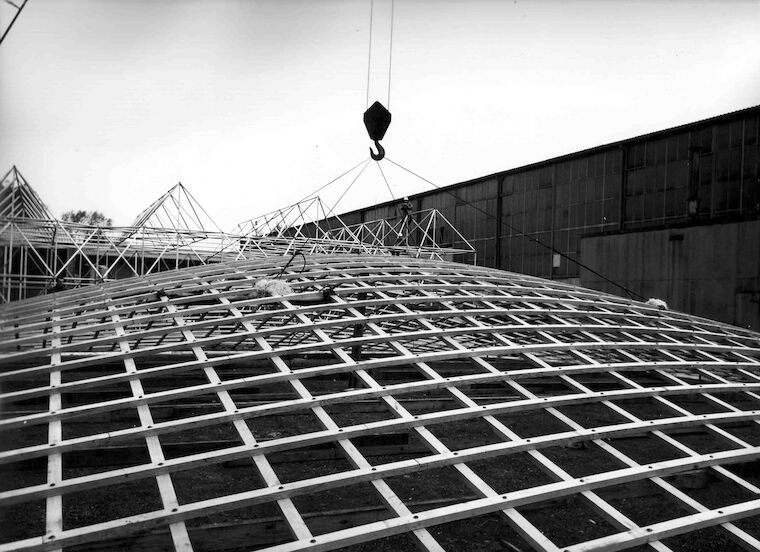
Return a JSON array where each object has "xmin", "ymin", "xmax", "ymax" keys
[{"xmin": 581, "ymin": 220, "xmax": 760, "ymax": 331}]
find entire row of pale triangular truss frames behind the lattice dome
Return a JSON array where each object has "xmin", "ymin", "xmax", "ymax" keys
[{"xmin": 0, "ymin": 167, "xmax": 474, "ymax": 303}]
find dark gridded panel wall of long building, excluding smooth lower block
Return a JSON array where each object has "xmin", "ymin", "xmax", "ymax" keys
[{"xmin": 338, "ymin": 106, "xmax": 760, "ymax": 298}]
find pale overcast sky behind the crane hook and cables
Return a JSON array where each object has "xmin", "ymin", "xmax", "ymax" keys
[{"xmin": 0, "ymin": 0, "xmax": 760, "ymax": 229}]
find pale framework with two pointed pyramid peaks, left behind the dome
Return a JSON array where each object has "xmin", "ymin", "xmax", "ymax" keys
[{"xmin": 0, "ymin": 172, "xmax": 242, "ymax": 302}]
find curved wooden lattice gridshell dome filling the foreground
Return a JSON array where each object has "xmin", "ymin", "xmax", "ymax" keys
[{"xmin": 0, "ymin": 255, "xmax": 760, "ymax": 552}]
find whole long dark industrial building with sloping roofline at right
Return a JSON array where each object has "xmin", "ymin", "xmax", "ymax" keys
[{"xmin": 341, "ymin": 106, "xmax": 760, "ymax": 329}]
